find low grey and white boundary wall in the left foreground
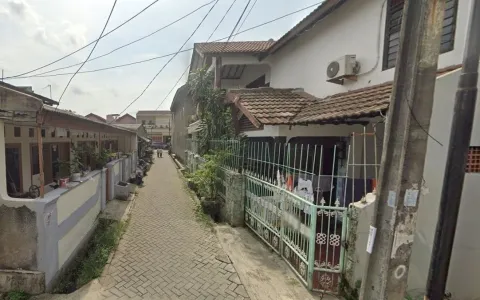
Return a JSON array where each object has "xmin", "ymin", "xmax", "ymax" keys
[{"xmin": 0, "ymin": 169, "xmax": 107, "ymax": 293}]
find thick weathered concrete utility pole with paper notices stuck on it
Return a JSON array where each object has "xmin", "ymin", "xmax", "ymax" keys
[{"xmin": 360, "ymin": 0, "xmax": 445, "ymax": 300}]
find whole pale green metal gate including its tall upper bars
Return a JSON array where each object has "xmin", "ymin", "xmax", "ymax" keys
[{"xmin": 244, "ymin": 143, "xmax": 348, "ymax": 293}]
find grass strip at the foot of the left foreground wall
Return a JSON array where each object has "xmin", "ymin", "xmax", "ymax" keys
[{"xmin": 54, "ymin": 219, "xmax": 128, "ymax": 294}]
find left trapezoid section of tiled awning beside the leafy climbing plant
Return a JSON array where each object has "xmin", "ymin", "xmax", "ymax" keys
[{"xmin": 227, "ymin": 88, "xmax": 315, "ymax": 125}]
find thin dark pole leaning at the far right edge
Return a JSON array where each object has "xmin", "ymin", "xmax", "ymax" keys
[{"xmin": 425, "ymin": 0, "xmax": 480, "ymax": 300}]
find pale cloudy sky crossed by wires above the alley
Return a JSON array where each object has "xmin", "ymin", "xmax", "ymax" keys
[{"xmin": 0, "ymin": 0, "xmax": 320, "ymax": 116}]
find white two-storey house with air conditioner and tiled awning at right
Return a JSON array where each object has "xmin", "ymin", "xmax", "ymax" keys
[{"xmin": 171, "ymin": 0, "xmax": 480, "ymax": 299}]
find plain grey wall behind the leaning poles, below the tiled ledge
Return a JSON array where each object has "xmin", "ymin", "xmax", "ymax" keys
[{"xmin": 408, "ymin": 71, "xmax": 480, "ymax": 300}]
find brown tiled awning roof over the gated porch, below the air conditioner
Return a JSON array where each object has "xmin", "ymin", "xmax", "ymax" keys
[{"xmin": 231, "ymin": 65, "xmax": 461, "ymax": 128}]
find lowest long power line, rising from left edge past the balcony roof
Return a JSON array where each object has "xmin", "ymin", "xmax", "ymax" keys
[{"xmin": 5, "ymin": 2, "xmax": 321, "ymax": 80}]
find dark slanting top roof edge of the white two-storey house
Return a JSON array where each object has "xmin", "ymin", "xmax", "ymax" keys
[{"xmin": 259, "ymin": 0, "xmax": 348, "ymax": 60}]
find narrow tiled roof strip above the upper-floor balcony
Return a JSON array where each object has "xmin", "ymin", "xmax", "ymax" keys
[{"xmin": 195, "ymin": 40, "xmax": 275, "ymax": 54}]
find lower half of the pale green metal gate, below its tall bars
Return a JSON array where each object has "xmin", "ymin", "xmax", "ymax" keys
[{"xmin": 245, "ymin": 175, "xmax": 347, "ymax": 292}]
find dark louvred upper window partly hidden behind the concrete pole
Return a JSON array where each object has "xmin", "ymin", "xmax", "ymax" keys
[{"xmin": 383, "ymin": 0, "xmax": 458, "ymax": 70}]
